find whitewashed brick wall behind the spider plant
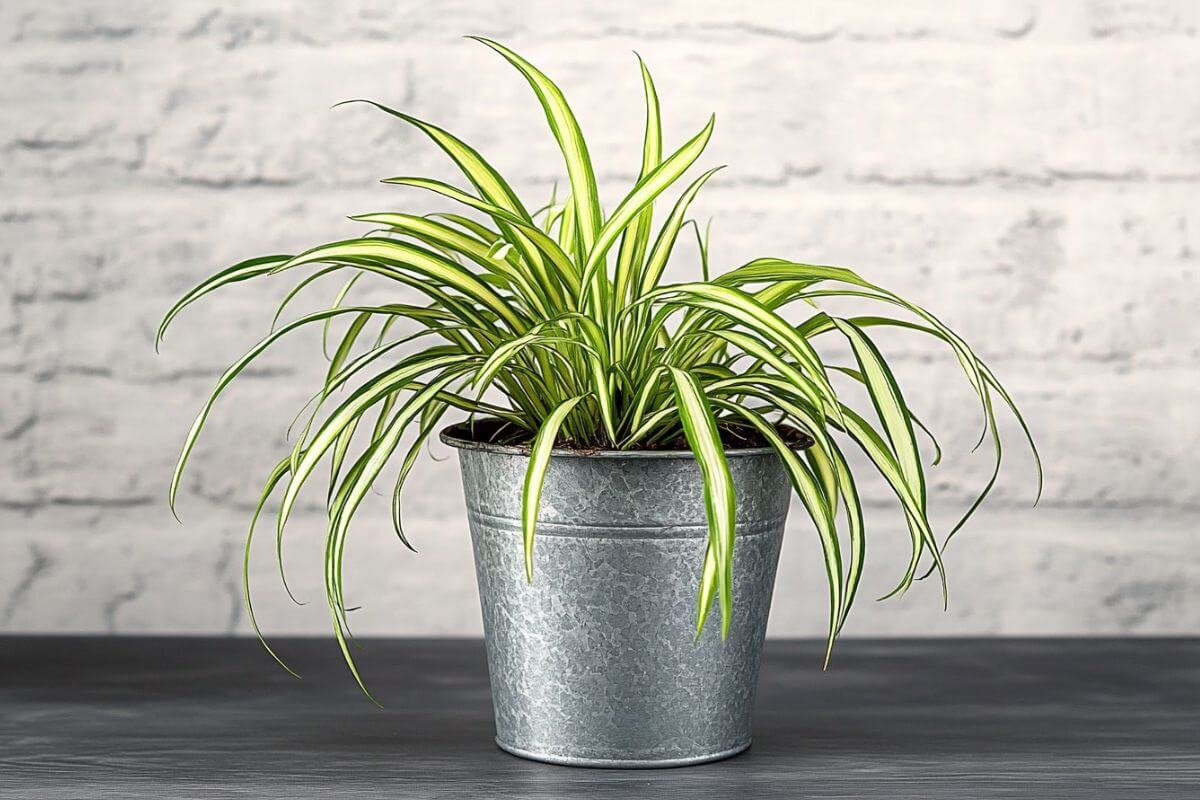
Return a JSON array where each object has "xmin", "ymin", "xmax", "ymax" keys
[{"xmin": 0, "ymin": 0, "xmax": 1200, "ymax": 634}]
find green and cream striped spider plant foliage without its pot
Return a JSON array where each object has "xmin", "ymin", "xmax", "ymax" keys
[{"xmin": 156, "ymin": 38, "xmax": 1040, "ymax": 691}]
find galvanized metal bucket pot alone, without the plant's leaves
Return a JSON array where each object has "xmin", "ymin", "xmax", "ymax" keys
[{"xmin": 442, "ymin": 426, "xmax": 788, "ymax": 768}]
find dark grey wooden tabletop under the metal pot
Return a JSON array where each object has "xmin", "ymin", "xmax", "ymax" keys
[{"xmin": 0, "ymin": 637, "xmax": 1200, "ymax": 800}]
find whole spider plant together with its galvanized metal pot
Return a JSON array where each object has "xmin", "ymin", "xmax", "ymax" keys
[{"xmin": 158, "ymin": 40, "xmax": 1040, "ymax": 766}]
